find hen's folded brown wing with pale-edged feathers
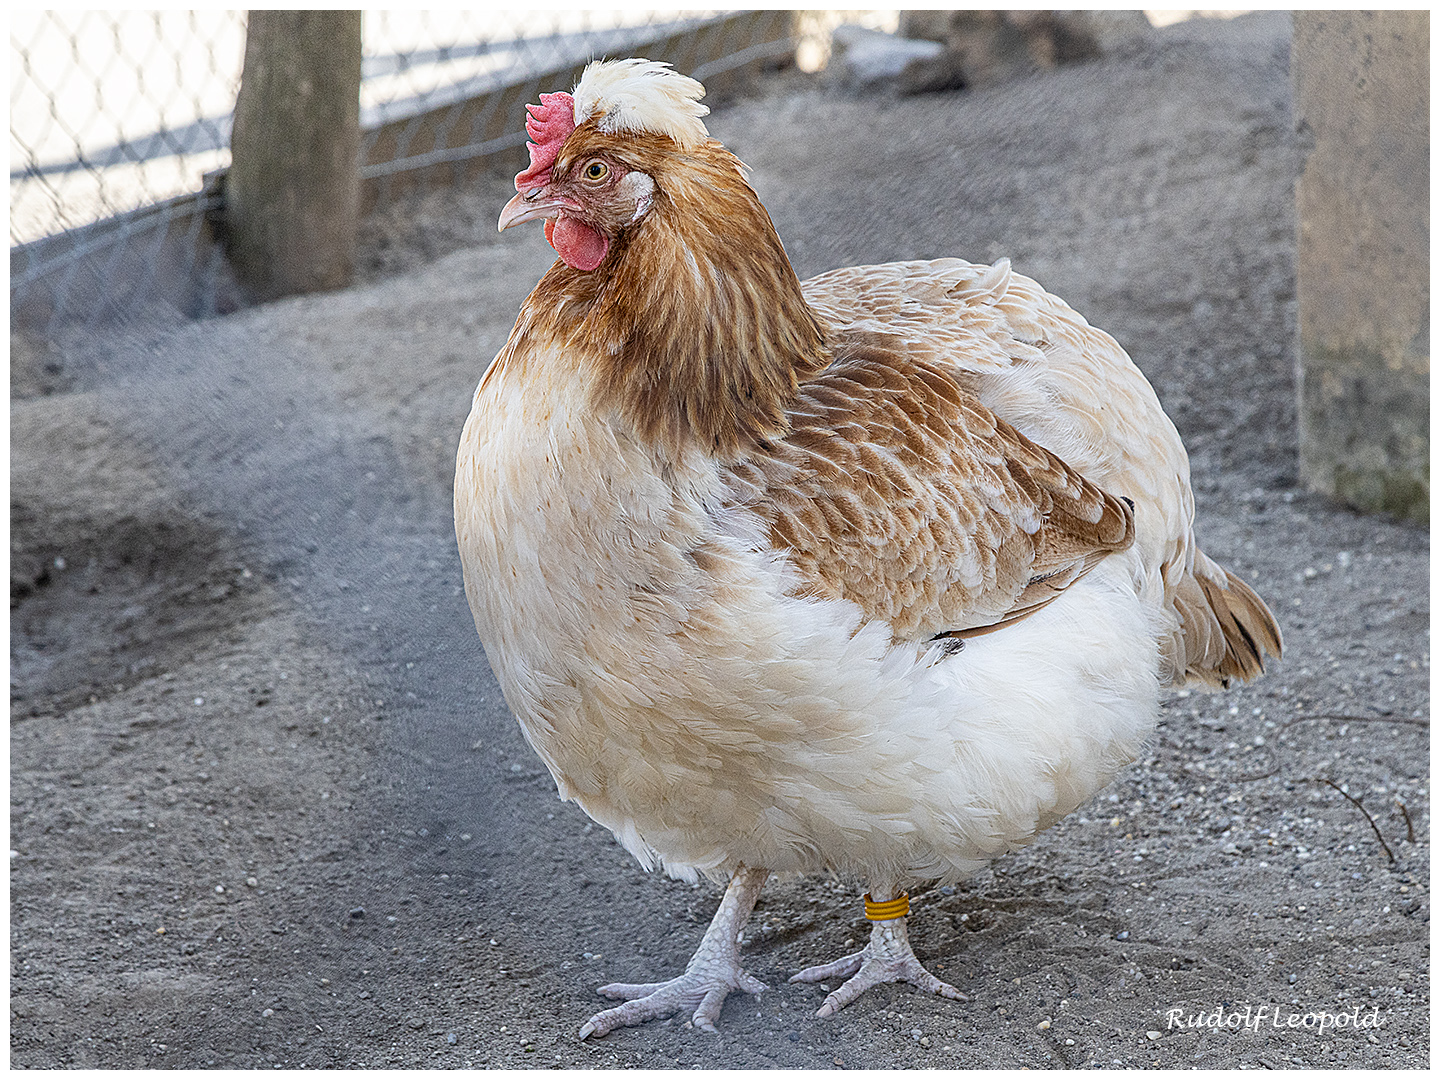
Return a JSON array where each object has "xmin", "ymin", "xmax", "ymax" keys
[{"xmin": 734, "ymin": 341, "xmax": 1135, "ymax": 639}]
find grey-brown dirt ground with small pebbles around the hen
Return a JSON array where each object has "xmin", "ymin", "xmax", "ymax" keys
[{"xmin": 10, "ymin": 13, "xmax": 1430, "ymax": 1068}]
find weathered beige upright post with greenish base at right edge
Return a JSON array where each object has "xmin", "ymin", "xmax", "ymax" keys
[{"xmin": 1290, "ymin": 12, "xmax": 1430, "ymax": 521}]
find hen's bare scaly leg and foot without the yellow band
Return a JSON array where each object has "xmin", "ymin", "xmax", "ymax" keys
[{"xmin": 580, "ymin": 865, "xmax": 770, "ymax": 1038}]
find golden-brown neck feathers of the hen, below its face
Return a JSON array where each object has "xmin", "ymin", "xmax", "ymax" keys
[{"xmin": 536, "ymin": 137, "xmax": 831, "ymax": 461}]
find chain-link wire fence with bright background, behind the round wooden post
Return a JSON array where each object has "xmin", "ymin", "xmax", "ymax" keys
[{"xmin": 10, "ymin": 10, "xmax": 884, "ymax": 333}]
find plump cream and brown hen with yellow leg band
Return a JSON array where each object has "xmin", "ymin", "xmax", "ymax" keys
[{"xmin": 455, "ymin": 60, "xmax": 1280, "ymax": 1037}]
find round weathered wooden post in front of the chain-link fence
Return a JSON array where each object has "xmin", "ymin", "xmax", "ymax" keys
[{"xmin": 225, "ymin": 10, "xmax": 360, "ymax": 301}]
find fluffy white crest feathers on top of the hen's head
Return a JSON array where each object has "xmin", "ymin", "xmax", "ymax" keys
[{"xmin": 575, "ymin": 59, "xmax": 710, "ymax": 150}]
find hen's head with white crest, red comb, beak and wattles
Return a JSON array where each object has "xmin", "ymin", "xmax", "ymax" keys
[{"xmin": 500, "ymin": 60, "xmax": 708, "ymax": 271}]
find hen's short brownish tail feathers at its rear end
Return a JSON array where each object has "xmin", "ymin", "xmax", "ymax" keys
[{"xmin": 1174, "ymin": 553, "xmax": 1284, "ymax": 688}]
